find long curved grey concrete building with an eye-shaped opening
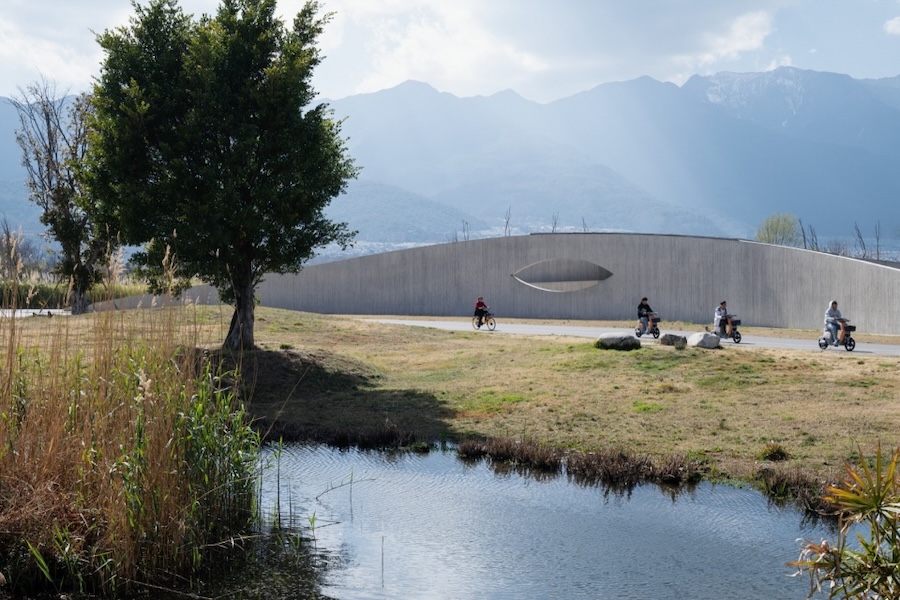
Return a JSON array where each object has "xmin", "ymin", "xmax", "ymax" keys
[{"xmin": 258, "ymin": 233, "xmax": 900, "ymax": 334}]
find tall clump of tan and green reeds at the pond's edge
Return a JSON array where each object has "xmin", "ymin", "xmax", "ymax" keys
[{"xmin": 0, "ymin": 302, "xmax": 259, "ymax": 596}]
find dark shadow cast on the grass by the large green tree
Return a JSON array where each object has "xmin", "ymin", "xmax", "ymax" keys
[{"xmin": 219, "ymin": 349, "xmax": 452, "ymax": 448}]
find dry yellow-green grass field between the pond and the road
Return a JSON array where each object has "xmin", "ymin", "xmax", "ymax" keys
[{"xmin": 23, "ymin": 307, "xmax": 900, "ymax": 478}]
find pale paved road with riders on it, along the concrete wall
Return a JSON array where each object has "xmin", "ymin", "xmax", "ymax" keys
[{"xmin": 364, "ymin": 317, "xmax": 900, "ymax": 356}]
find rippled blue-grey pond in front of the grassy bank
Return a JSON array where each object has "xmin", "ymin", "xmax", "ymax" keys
[{"xmin": 262, "ymin": 446, "xmax": 835, "ymax": 600}]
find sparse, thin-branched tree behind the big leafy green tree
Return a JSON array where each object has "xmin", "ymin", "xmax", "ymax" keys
[{"xmin": 12, "ymin": 80, "xmax": 113, "ymax": 314}]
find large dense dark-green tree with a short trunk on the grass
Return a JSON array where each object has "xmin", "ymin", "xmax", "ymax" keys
[{"xmin": 90, "ymin": 0, "xmax": 357, "ymax": 349}]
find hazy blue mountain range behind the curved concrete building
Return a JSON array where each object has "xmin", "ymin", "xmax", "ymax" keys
[{"xmin": 0, "ymin": 67, "xmax": 900, "ymax": 252}]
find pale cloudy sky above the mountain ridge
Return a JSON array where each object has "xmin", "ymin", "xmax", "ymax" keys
[{"xmin": 0, "ymin": 0, "xmax": 900, "ymax": 103}]
